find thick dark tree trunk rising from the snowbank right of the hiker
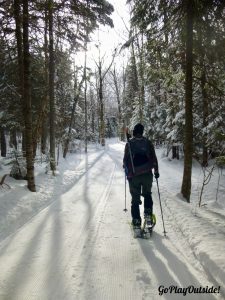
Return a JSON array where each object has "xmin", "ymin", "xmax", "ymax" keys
[{"xmin": 181, "ymin": 0, "xmax": 194, "ymax": 202}]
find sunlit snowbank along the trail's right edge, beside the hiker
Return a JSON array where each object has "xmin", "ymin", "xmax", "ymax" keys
[{"xmin": 158, "ymin": 150, "xmax": 225, "ymax": 297}]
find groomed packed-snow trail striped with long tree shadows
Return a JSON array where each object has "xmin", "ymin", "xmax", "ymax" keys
[{"xmin": 0, "ymin": 144, "xmax": 222, "ymax": 300}]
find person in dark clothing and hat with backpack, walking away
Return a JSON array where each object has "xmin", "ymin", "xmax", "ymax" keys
[{"xmin": 123, "ymin": 123, "xmax": 159, "ymax": 228}]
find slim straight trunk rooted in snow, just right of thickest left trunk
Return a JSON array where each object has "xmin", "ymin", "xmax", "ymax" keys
[{"xmin": 48, "ymin": 0, "xmax": 56, "ymax": 174}]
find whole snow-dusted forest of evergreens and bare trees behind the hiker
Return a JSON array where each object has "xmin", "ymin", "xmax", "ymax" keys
[{"xmin": 0, "ymin": 0, "xmax": 225, "ymax": 202}]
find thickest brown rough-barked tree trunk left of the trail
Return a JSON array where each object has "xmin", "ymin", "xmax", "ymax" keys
[{"xmin": 23, "ymin": 0, "xmax": 36, "ymax": 192}]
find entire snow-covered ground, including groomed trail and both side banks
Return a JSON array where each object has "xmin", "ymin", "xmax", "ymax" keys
[{"xmin": 0, "ymin": 140, "xmax": 225, "ymax": 300}]
